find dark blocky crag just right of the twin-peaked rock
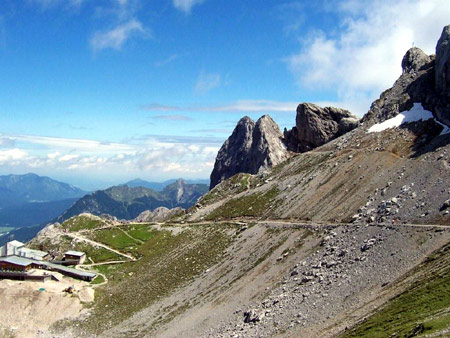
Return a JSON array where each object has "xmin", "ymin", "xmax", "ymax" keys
[{"xmin": 284, "ymin": 103, "xmax": 358, "ymax": 152}]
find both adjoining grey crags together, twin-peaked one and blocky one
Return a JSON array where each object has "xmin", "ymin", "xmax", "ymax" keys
[{"xmin": 210, "ymin": 107, "xmax": 358, "ymax": 189}]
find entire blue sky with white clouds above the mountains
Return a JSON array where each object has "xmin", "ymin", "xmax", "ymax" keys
[{"xmin": 0, "ymin": 0, "xmax": 450, "ymax": 189}]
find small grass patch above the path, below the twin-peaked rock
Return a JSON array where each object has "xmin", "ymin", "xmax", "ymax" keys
[{"xmin": 206, "ymin": 188, "xmax": 278, "ymax": 220}]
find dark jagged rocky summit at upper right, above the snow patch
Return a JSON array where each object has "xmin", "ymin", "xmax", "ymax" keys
[{"xmin": 362, "ymin": 25, "xmax": 450, "ymax": 127}]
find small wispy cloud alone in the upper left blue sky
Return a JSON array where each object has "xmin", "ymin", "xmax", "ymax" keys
[{"xmin": 90, "ymin": 19, "xmax": 148, "ymax": 51}]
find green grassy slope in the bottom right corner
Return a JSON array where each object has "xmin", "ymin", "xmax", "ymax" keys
[{"xmin": 341, "ymin": 245, "xmax": 450, "ymax": 338}]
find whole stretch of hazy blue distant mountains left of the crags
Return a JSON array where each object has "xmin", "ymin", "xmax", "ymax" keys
[{"xmin": 0, "ymin": 174, "xmax": 209, "ymax": 245}]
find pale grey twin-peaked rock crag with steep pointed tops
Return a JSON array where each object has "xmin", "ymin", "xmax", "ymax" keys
[{"xmin": 210, "ymin": 115, "xmax": 289, "ymax": 189}]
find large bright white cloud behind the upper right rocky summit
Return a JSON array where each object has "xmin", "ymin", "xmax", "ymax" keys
[{"xmin": 286, "ymin": 0, "xmax": 450, "ymax": 115}]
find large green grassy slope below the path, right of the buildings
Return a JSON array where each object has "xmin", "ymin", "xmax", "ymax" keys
[{"xmin": 51, "ymin": 218, "xmax": 235, "ymax": 335}]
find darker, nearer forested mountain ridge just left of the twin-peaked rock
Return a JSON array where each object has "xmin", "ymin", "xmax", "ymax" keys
[{"xmin": 58, "ymin": 179, "xmax": 208, "ymax": 222}]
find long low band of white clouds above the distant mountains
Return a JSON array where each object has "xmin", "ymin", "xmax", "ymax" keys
[{"xmin": 0, "ymin": 135, "xmax": 219, "ymax": 179}]
